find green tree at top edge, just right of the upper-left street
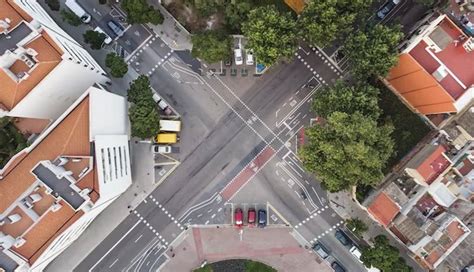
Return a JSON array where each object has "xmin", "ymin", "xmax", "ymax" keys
[{"xmin": 122, "ymin": 0, "xmax": 165, "ymax": 25}]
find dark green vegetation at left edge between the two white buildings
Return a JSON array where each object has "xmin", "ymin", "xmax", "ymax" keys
[{"xmin": 0, "ymin": 117, "xmax": 27, "ymax": 168}]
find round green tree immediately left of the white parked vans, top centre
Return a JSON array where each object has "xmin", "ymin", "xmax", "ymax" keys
[{"xmin": 191, "ymin": 30, "xmax": 232, "ymax": 63}]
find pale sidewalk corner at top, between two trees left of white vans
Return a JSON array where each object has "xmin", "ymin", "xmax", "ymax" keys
[{"xmin": 147, "ymin": 1, "xmax": 193, "ymax": 51}]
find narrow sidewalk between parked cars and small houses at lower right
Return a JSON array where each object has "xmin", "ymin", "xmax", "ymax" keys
[{"xmin": 328, "ymin": 191, "xmax": 424, "ymax": 271}]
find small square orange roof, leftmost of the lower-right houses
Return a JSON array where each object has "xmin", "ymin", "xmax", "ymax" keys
[{"xmin": 368, "ymin": 192, "xmax": 400, "ymax": 227}]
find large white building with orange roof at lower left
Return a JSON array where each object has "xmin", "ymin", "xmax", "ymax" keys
[{"xmin": 0, "ymin": 86, "xmax": 131, "ymax": 271}]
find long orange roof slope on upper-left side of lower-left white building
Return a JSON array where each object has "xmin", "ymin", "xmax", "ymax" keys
[{"xmin": 0, "ymin": 97, "xmax": 91, "ymax": 212}]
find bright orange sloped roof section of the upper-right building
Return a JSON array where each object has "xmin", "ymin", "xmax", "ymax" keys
[{"xmin": 387, "ymin": 54, "xmax": 456, "ymax": 114}]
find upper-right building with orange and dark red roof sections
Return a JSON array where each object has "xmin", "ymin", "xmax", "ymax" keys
[{"xmin": 384, "ymin": 15, "xmax": 474, "ymax": 126}]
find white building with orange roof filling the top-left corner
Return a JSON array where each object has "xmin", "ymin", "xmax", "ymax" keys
[{"xmin": 0, "ymin": 0, "xmax": 108, "ymax": 120}]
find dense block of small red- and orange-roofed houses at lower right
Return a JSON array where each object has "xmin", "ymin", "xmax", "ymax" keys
[{"xmin": 364, "ymin": 108, "xmax": 474, "ymax": 269}]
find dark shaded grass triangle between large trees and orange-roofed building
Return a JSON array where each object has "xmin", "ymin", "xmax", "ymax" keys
[{"xmin": 377, "ymin": 82, "xmax": 431, "ymax": 173}]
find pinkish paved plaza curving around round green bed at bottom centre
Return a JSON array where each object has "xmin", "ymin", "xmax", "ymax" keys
[{"xmin": 160, "ymin": 227, "xmax": 332, "ymax": 272}]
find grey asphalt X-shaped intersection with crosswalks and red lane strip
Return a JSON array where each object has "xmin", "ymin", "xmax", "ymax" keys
[{"xmin": 54, "ymin": 2, "xmax": 426, "ymax": 271}]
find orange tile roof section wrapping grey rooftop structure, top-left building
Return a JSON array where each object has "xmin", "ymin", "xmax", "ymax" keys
[{"xmin": 0, "ymin": 36, "xmax": 62, "ymax": 110}]
